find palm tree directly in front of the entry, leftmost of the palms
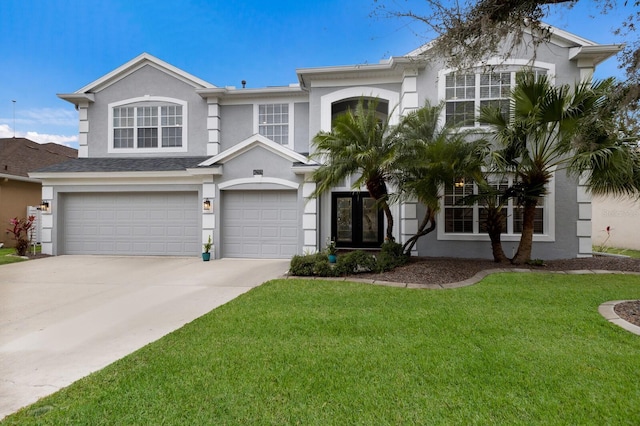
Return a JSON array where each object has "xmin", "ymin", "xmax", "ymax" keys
[{"xmin": 313, "ymin": 98, "xmax": 396, "ymax": 241}]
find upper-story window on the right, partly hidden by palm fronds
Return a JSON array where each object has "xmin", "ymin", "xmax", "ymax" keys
[{"xmin": 444, "ymin": 68, "xmax": 546, "ymax": 127}]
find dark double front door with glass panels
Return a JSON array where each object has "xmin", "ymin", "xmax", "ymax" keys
[{"xmin": 331, "ymin": 192, "xmax": 383, "ymax": 248}]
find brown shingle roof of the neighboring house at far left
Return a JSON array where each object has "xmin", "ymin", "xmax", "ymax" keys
[{"xmin": 0, "ymin": 138, "xmax": 78, "ymax": 180}]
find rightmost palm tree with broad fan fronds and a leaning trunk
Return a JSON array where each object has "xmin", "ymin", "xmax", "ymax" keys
[{"xmin": 480, "ymin": 73, "xmax": 638, "ymax": 264}]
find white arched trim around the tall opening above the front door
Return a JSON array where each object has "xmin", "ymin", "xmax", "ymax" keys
[{"xmin": 320, "ymin": 86, "xmax": 400, "ymax": 132}]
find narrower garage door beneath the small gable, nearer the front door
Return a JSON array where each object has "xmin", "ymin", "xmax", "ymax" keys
[{"xmin": 221, "ymin": 191, "xmax": 300, "ymax": 259}]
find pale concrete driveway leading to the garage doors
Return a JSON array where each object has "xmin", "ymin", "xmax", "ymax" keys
[{"xmin": 0, "ymin": 256, "xmax": 289, "ymax": 419}]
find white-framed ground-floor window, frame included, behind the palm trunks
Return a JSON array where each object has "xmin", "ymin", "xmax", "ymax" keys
[{"xmin": 438, "ymin": 172, "xmax": 555, "ymax": 241}]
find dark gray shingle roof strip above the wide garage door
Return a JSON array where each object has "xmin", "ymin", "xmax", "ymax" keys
[{"xmin": 37, "ymin": 157, "xmax": 209, "ymax": 173}]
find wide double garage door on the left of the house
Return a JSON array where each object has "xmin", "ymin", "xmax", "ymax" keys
[{"xmin": 60, "ymin": 192, "xmax": 202, "ymax": 256}]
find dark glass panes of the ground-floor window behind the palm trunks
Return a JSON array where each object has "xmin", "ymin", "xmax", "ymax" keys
[{"xmin": 443, "ymin": 177, "xmax": 546, "ymax": 235}]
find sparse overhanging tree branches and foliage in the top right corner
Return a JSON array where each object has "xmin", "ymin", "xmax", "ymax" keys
[{"xmin": 373, "ymin": 0, "xmax": 640, "ymax": 136}]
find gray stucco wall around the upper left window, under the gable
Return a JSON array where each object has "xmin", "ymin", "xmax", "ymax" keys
[{"xmin": 88, "ymin": 65, "xmax": 208, "ymax": 157}]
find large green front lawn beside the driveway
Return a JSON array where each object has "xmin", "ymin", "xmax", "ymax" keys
[{"xmin": 6, "ymin": 273, "xmax": 640, "ymax": 425}]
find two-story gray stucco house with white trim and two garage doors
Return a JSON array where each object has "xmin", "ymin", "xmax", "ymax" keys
[{"xmin": 32, "ymin": 29, "xmax": 619, "ymax": 259}]
